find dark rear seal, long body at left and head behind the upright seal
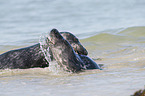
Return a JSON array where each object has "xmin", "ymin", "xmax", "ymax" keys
[{"xmin": 0, "ymin": 32, "xmax": 88, "ymax": 69}]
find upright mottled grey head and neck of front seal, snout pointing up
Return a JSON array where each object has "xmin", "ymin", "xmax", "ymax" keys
[{"xmin": 48, "ymin": 29, "xmax": 84, "ymax": 72}]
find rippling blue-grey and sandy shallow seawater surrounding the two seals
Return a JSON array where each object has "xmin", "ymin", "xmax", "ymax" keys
[{"xmin": 0, "ymin": 0, "xmax": 145, "ymax": 96}]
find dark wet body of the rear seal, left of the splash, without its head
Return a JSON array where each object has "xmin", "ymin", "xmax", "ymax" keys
[{"xmin": 0, "ymin": 43, "xmax": 48, "ymax": 69}]
